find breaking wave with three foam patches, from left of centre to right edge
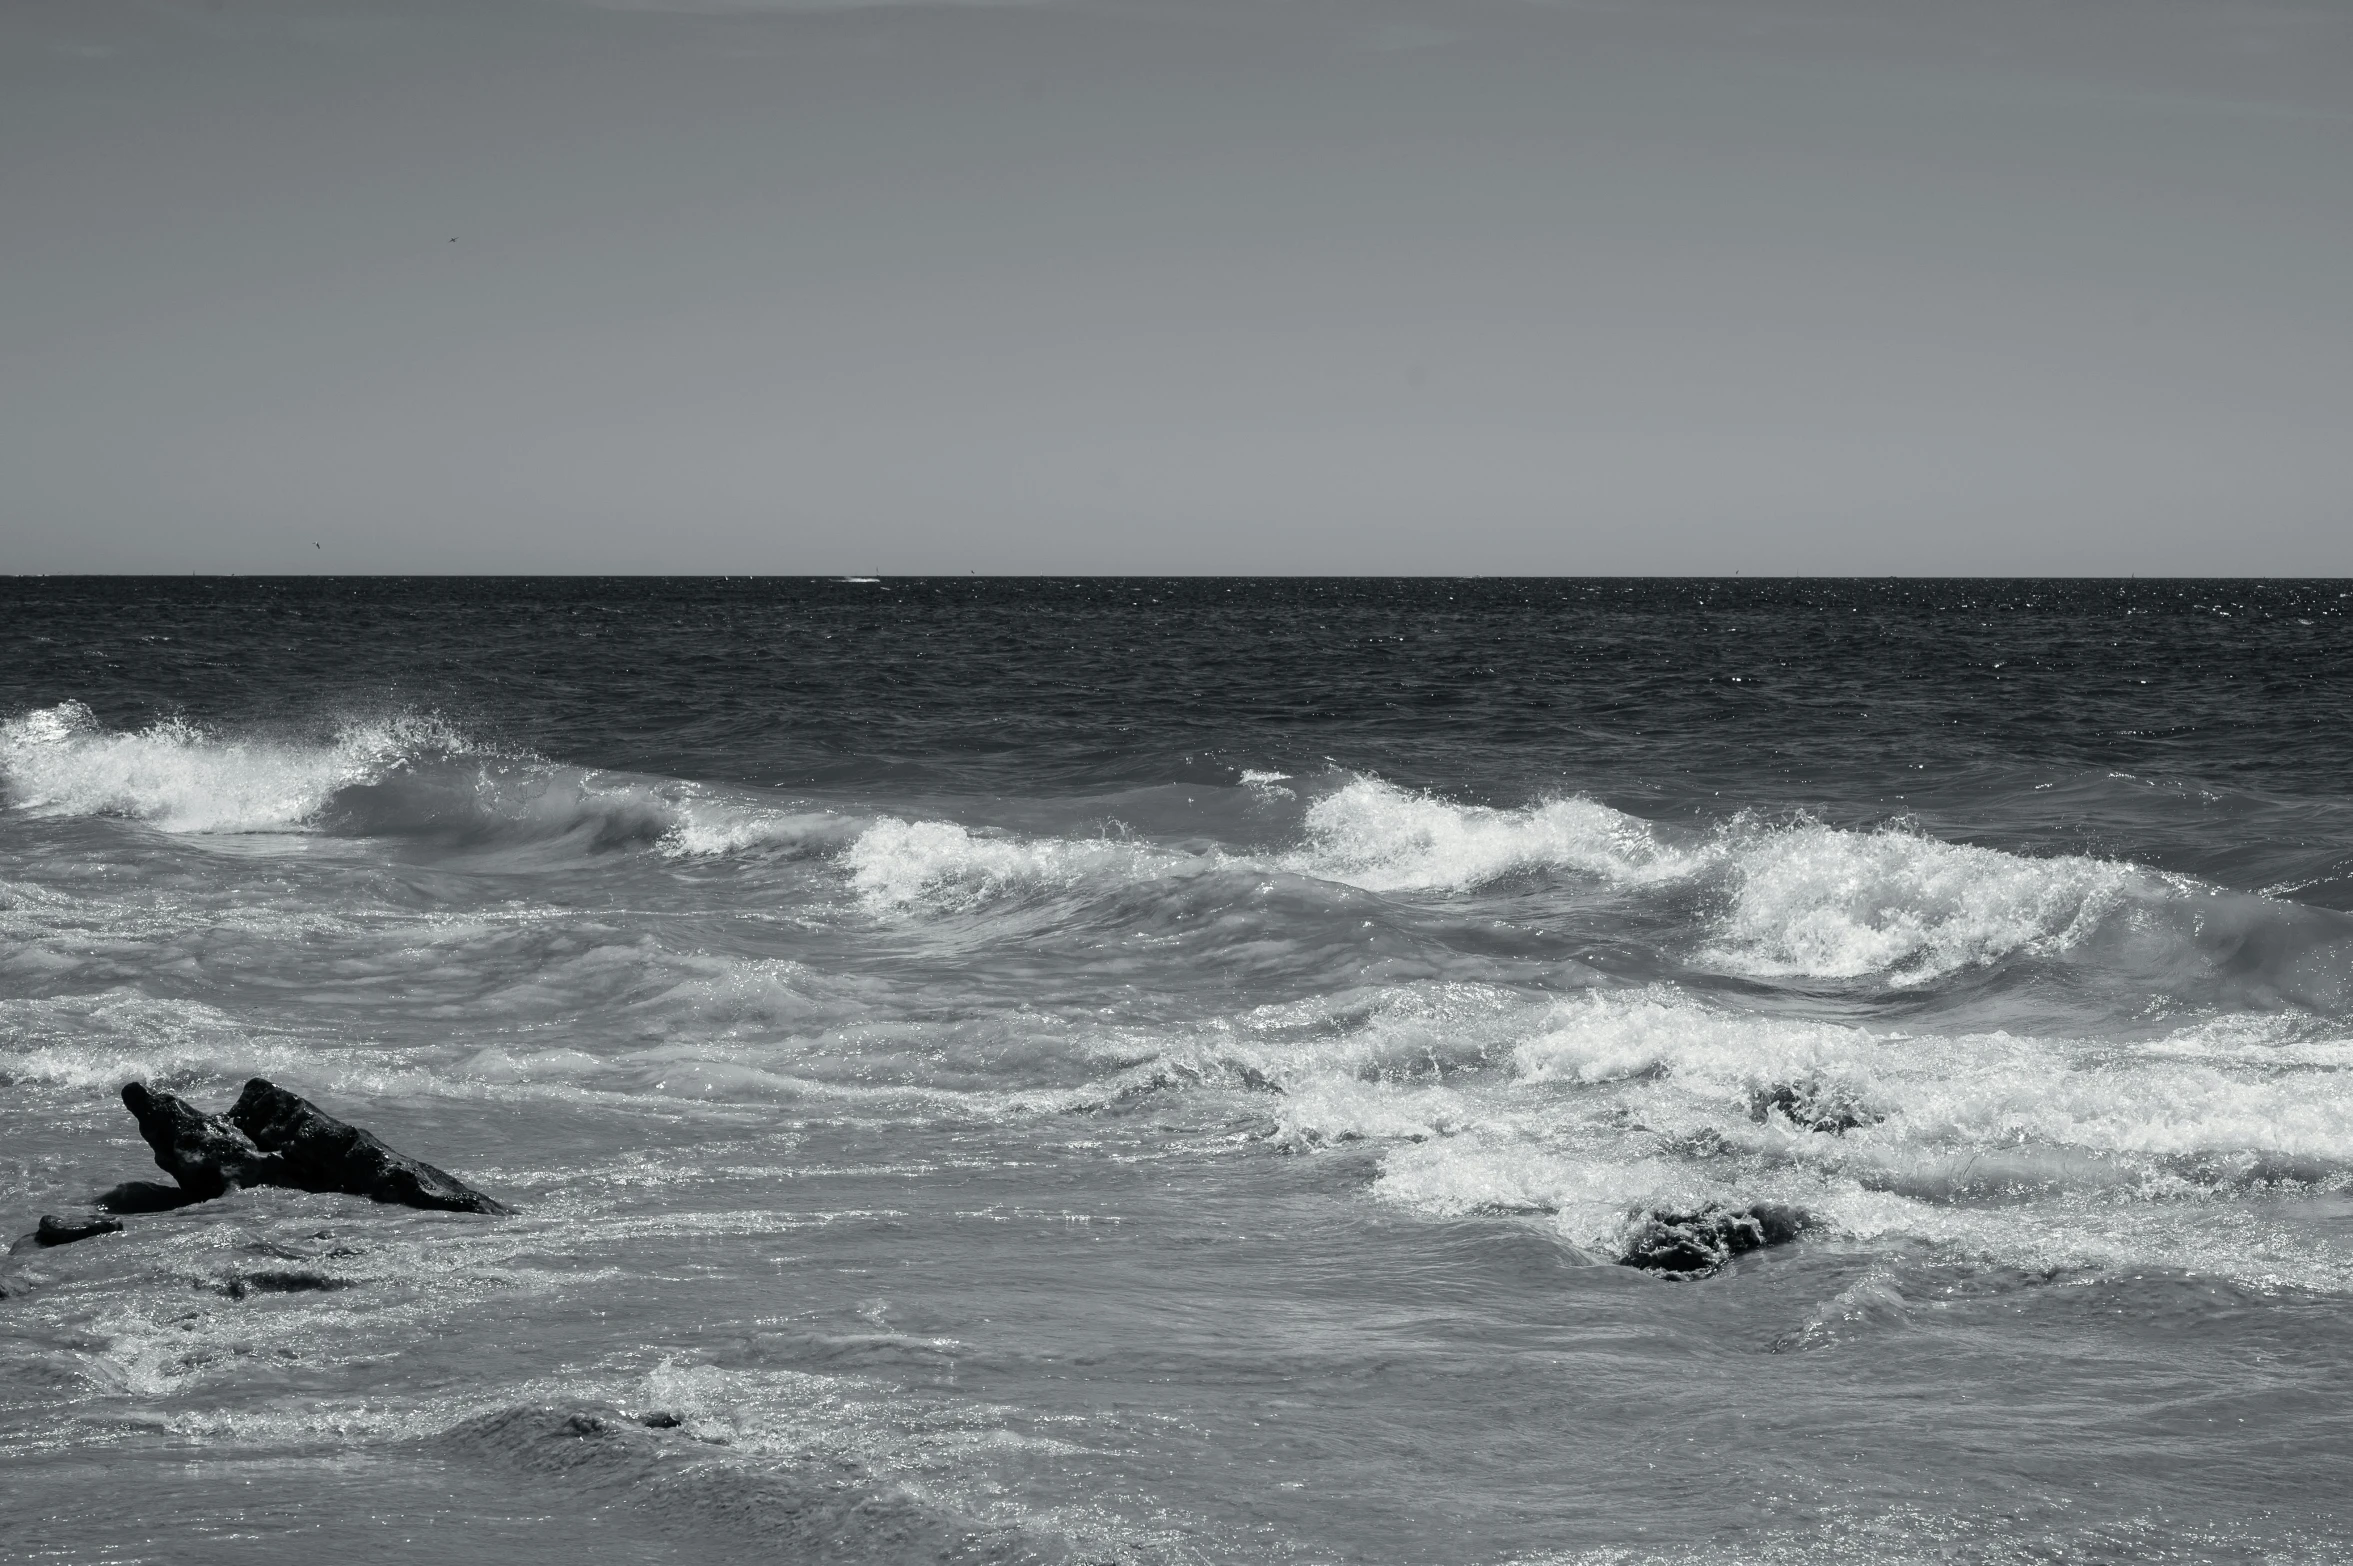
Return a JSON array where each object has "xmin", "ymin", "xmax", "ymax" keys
[{"xmin": 842, "ymin": 778, "xmax": 2353, "ymax": 992}]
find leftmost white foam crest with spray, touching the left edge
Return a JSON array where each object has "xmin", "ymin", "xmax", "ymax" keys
[{"xmin": 0, "ymin": 701, "xmax": 471, "ymax": 832}]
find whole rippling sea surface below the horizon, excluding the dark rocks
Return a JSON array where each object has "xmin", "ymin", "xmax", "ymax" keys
[{"xmin": 0, "ymin": 578, "xmax": 2353, "ymax": 1566}]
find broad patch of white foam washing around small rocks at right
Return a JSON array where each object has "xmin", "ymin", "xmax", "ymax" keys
[{"xmin": 1327, "ymin": 988, "xmax": 2353, "ymax": 1289}]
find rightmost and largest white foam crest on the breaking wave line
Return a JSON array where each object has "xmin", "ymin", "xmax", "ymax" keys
[{"xmin": 1701, "ymin": 823, "xmax": 2162, "ymax": 985}]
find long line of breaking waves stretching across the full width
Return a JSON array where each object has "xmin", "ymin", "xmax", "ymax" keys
[{"xmin": 13, "ymin": 703, "xmax": 2353, "ymax": 987}]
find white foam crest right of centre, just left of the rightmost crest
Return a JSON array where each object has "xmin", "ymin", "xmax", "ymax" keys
[{"xmin": 1285, "ymin": 778, "xmax": 1706, "ymax": 891}]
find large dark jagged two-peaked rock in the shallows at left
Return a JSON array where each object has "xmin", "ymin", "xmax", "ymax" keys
[{"xmin": 106, "ymin": 1077, "xmax": 513, "ymax": 1213}]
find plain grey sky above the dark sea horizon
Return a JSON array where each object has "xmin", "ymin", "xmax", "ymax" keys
[{"xmin": 0, "ymin": 0, "xmax": 2353, "ymax": 574}]
